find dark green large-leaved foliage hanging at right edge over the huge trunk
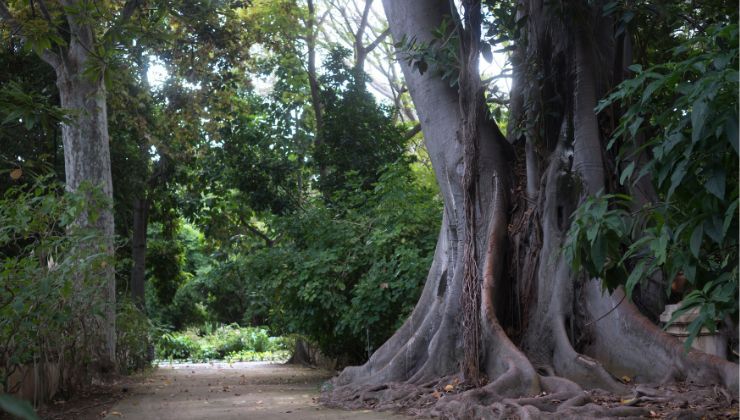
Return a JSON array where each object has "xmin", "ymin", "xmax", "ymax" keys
[{"xmin": 565, "ymin": 24, "xmax": 738, "ymax": 346}]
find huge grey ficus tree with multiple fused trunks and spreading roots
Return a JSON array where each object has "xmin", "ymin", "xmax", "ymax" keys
[{"xmin": 325, "ymin": 0, "xmax": 738, "ymax": 418}]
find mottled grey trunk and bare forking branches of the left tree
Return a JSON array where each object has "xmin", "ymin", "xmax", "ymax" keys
[{"xmin": 0, "ymin": 0, "xmax": 120, "ymax": 378}]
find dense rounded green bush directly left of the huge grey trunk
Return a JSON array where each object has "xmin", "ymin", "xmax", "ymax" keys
[{"xmin": 264, "ymin": 164, "xmax": 441, "ymax": 360}]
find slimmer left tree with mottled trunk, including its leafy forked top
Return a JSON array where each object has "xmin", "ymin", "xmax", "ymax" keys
[{"xmin": 0, "ymin": 0, "xmax": 140, "ymax": 369}]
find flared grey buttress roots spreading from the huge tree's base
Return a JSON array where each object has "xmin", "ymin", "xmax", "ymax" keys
[{"xmin": 322, "ymin": 142, "xmax": 737, "ymax": 419}]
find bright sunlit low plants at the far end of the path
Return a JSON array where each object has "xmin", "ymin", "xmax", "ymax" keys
[{"xmin": 156, "ymin": 324, "xmax": 290, "ymax": 361}]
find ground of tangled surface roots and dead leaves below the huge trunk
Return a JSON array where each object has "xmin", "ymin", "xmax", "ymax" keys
[{"xmin": 321, "ymin": 376, "xmax": 738, "ymax": 420}]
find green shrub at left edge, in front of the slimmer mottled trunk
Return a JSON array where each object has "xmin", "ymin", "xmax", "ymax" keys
[{"xmin": 0, "ymin": 179, "xmax": 111, "ymax": 392}]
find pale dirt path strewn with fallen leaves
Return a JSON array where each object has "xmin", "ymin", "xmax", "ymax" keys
[{"xmin": 99, "ymin": 362, "xmax": 407, "ymax": 420}]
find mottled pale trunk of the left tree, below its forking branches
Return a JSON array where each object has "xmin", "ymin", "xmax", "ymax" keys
[{"xmin": 55, "ymin": 38, "xmax": 116, "ymax": 370}]
